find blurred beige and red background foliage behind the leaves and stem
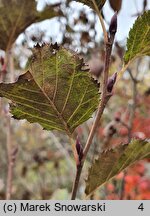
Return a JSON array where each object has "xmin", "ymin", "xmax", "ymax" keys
[{"xmin": 0, "ymin": 0, "xmax": 150, "ymax": 199}]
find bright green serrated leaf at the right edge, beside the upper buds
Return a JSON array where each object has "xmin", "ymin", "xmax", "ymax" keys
[{"xmin": 124, "ymin": 10, "xmax": 150, "ymax": 64}]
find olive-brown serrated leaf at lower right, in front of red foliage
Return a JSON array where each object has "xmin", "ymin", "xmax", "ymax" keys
[{"xmin": 85, "ymin": 140, "xmax": 150, "ymax": 195}]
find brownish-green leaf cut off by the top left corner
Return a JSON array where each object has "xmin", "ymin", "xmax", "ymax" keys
[{"xmin": 0, "ymin": 0, "xmax": 61, "ymax": 50}]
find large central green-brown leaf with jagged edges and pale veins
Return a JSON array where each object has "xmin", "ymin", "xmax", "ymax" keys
[{"xmin": 0, "ymin": 44, "xmax": 99, "ymax": 134}]
